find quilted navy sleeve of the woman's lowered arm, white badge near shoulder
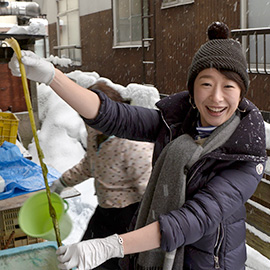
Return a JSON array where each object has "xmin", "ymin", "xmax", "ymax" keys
[{"xmin": 159, "ymin": 161, "xmax": 265, "ymax": 251}]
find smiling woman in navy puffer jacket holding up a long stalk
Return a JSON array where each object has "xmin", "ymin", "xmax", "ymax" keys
[{"xmin": 10, "ymin": 22, "xmax": 267, "ymax": 270}]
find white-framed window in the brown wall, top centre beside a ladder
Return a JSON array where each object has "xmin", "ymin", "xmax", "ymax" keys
[{"xmin": 113, "ymin": 0, "xmax": 148, "ymax": 47}]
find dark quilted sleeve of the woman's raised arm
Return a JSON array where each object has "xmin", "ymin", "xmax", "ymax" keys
[{"xmin": 83, "ymin": 90, "xmax": 161, "ymax": 142}]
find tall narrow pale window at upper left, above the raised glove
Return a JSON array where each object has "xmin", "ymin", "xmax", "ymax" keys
[{"xmin": 54, "ymin": 0, "xmax": 81, "ymax": 65}]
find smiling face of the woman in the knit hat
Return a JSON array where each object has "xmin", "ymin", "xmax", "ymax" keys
[{"xmin": 194, "ymin": 68, "xmax": 241, "ymax": 127}]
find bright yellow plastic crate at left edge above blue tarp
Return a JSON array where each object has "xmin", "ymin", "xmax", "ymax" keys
[{"xmin": 0, "ymin": 112, "xmax": 19, "ymax": 145}]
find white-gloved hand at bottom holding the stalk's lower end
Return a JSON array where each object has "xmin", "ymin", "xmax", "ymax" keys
[{"xmin": 56, "ymin": 234, "xmax": 124, "ymax": 270}]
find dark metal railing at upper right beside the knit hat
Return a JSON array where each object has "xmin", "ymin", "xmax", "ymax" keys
[{"xmin": 231, "ymin": 27, "xmax": 270, "ymax": 74}]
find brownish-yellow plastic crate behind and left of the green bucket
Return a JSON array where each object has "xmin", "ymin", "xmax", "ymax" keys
[{"xmin": 0, "ymin": 207, "xmax": 44, "ymax": 250}]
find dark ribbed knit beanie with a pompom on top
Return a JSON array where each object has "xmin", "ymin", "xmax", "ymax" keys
[{"xmin": 187, "ymin": 22, "xmax": 249, "ymax": 97}]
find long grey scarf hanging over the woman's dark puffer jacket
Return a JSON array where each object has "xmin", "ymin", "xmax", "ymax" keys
[{"xmin": 136, "ymin": 115, "xmax": 240, "ymax": 270}]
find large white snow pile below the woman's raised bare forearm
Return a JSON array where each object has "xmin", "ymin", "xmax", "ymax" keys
[{"xmin": 28, "ymin": 84, "xmax": 87, "ymax": 173}]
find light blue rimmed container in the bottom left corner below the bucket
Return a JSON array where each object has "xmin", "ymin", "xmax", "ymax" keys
[{"xmin": 0, "ymin": 241, "xmax": 59, "ymax": 270}]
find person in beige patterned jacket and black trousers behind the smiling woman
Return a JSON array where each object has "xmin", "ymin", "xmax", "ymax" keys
[{"xmin": 51, "ymin": 81, "xmax": 154, "ymax": 270}]
